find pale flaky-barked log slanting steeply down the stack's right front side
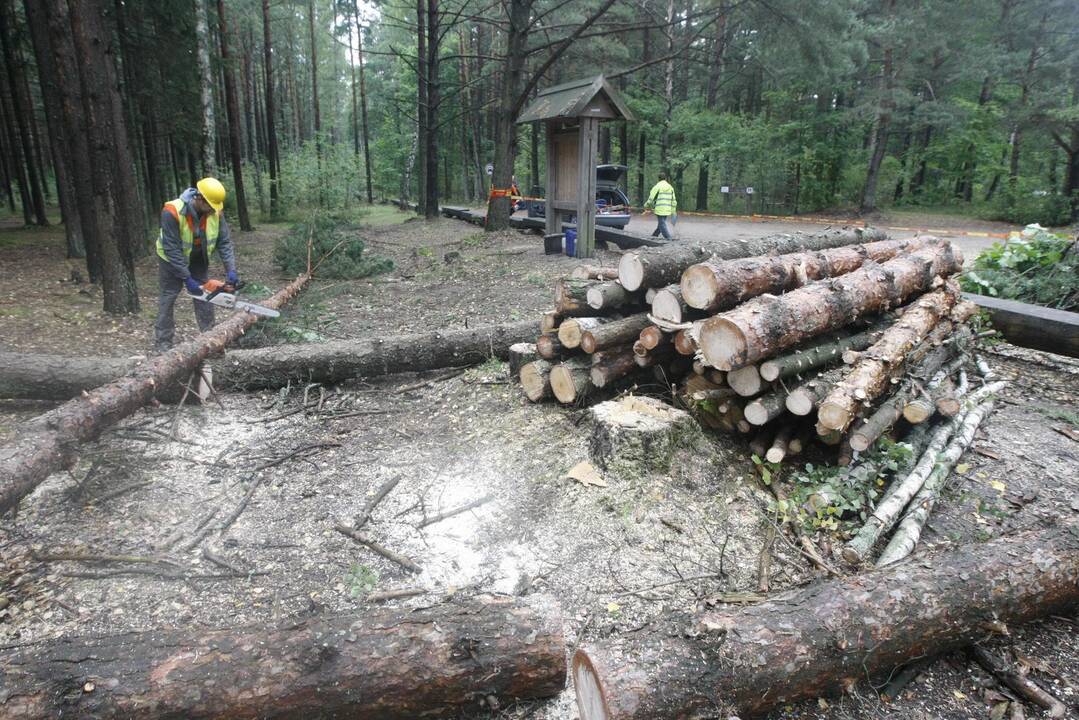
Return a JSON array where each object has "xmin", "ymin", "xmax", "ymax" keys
[{"xmin": 817, "ymin": 285, "xmax": 958, "ymax": 431}]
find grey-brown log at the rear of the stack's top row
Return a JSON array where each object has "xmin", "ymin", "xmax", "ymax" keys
[{"xmin": 618, "ymin": 228, "xmax": 886, "ymax": 290}]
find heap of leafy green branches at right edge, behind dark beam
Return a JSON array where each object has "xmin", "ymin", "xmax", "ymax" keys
[{"xmin": 961, "ymin": 225, "xmax": 1079, "ymax": 310}]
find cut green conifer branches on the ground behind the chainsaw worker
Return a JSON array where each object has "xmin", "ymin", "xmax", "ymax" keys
[{"xmin": 273, "ymin": 215, "xmax": 394, "ymax": 280}]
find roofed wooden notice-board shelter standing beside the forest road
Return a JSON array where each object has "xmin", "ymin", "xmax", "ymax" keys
[{"xmin": 517, "ymin": 76, "xmax": 633, "ymax": 258}]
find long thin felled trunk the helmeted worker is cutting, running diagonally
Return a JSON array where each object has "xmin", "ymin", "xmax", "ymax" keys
[{"xmin": 0, "ymin": 273, "xmax": 312, "ymax": 514}]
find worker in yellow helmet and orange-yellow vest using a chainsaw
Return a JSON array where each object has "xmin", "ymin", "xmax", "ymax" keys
[{"xmin": 153, "ymin": 177, "xmax": 240, "ymax": 352}]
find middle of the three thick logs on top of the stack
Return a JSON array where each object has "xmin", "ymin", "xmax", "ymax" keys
[{"xmin": 681, "ymin": 235, "xmax": 940, "ymax": 313}]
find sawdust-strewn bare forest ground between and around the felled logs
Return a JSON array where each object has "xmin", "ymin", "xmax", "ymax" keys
[{"xmin": 0, "ymin": 204, "xmax": 1079, "ymax": 720}]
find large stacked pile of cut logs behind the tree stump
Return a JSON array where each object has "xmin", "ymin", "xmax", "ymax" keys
[{"xmin": 511, "ymin": 229, "xmax": 975, "ymax": 470}]
